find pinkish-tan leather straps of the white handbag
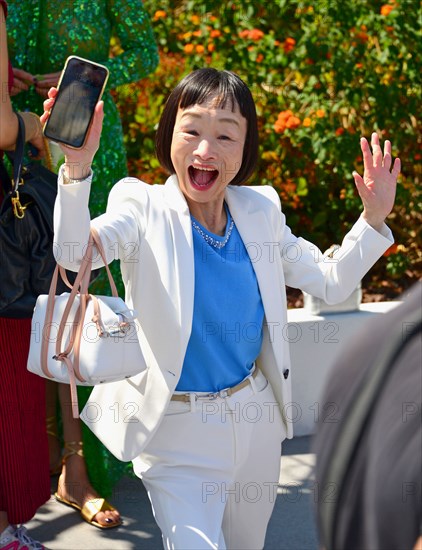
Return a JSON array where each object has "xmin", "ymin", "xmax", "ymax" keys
[{"xmin": 41, "ymin": 227, "xmax": 118, "ymax": 418}]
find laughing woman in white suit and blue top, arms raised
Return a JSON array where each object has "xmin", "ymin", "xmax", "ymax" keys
[{"xmin": 43, "ymin": 69, "xmax": 400, "ymax": 550}]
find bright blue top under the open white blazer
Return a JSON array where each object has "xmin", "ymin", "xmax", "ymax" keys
[{"xmin": 176, "ymin": 207, "xmax": 264, "ymax": 392}]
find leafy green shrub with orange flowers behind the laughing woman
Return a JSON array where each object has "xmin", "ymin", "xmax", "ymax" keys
[{"xmin": 116, "ymin": 0, "xmax": 421, "ymax": 288}]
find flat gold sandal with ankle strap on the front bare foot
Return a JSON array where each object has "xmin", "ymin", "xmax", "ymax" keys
[{"xmin": 54, "ymin": 441, "xmax": 122, "ymax": 529}]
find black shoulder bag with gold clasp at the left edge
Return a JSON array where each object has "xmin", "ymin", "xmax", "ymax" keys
[{"xmin": 0, "ymin": 115, "xmax": 66, "ymax": 318}]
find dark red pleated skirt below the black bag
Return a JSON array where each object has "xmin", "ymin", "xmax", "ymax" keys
[{"xmin": 0, "ymin": 317, "xmax": 50, "ymax": 524}]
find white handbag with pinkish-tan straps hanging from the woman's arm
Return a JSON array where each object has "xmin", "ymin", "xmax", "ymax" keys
[{"xmin": 27, "ymin": 228, "xmax": 146, "ymax": 418}]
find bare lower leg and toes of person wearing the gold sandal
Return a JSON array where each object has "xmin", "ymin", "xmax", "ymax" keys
[{"xmin": 57, "ymin": 384, "xmax": 120, "ymax": 527}]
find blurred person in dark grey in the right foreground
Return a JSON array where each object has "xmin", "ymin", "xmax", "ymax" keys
[{"xmin": 314, "ymin": 282, "xmax": 422, "ymax": 550}]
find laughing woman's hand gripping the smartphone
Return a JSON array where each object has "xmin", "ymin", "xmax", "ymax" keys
[{"xmin": 40, "ymin": 88, "xmax": 104, "ymax": 179}]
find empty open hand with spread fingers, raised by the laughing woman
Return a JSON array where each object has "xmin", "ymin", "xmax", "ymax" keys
[{"xmin": 353, "ymin": 132, "xmax": 400, "ymax": 230}]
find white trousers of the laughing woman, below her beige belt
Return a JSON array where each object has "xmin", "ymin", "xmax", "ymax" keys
[{"xmin": 133, "ymin": 373, "xmax": 285, "ymax": 550}]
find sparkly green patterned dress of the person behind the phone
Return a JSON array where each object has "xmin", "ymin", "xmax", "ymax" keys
[{"xmin": 7, "ymin": 0, "xmax": 158, "ymax": 496}]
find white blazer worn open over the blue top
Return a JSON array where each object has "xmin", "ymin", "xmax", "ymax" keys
[{"xmin": 55, "ymin": 173, "xmax": 393, "ymax": 461}]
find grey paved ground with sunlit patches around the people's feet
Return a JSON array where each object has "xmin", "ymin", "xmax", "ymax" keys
[{"xmin": 27, "ymin": 437, "xmax": 318, "ymax": 550}]
